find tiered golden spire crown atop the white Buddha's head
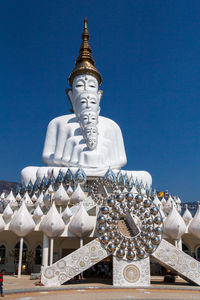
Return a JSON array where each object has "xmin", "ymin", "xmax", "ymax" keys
[{"xmin": 68, "ymin": 18, "xmax": 102, "ymax": 86}]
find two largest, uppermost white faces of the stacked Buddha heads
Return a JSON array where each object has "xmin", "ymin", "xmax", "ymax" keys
[{"xmin": 68, "ymin": 75, "xmax": 101, "ymax": 117}]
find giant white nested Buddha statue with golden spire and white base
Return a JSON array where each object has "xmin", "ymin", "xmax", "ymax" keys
[{"xmin": 21, "ymin": 20, "xmax": 152, "ymax": 186}]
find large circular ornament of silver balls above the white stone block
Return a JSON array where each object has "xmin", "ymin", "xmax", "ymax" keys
[{"xmin": 90, "ymin": 179, "xmax": 163, "ymax": 260}]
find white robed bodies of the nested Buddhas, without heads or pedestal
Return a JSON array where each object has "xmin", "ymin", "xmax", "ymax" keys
[{"xmin": 42, "ymin": 114, "xmax": 126, "ymax": 169}]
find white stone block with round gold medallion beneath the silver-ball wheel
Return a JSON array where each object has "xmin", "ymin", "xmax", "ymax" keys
[{"xmin": 113, "ymin": 256, "xmax": 150, "ymax": 287}]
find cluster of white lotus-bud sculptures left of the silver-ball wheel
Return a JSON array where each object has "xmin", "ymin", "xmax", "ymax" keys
[{"xmin": 0, "ymin": 184, "xmax": 94, "ymax": 237}]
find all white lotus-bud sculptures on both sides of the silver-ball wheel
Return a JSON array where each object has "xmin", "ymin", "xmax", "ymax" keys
[{"xmin": 0, "ymin": 183, "xmax": 200, "ymax": 240}]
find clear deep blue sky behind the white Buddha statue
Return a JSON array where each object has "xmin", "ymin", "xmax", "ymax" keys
[{"xmin": 0, "ymin": 0, "xmax": 200, "ymax": 201}]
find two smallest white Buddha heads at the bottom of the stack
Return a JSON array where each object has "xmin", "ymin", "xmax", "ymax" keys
[{"xmin": 83, "ymin": 124, "xmax": 98, "ymax": 150}]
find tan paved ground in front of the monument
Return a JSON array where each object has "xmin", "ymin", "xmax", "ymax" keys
[{"xmin": 1, "ymin": 275, "xmax": 200, "ymax": 300}]
